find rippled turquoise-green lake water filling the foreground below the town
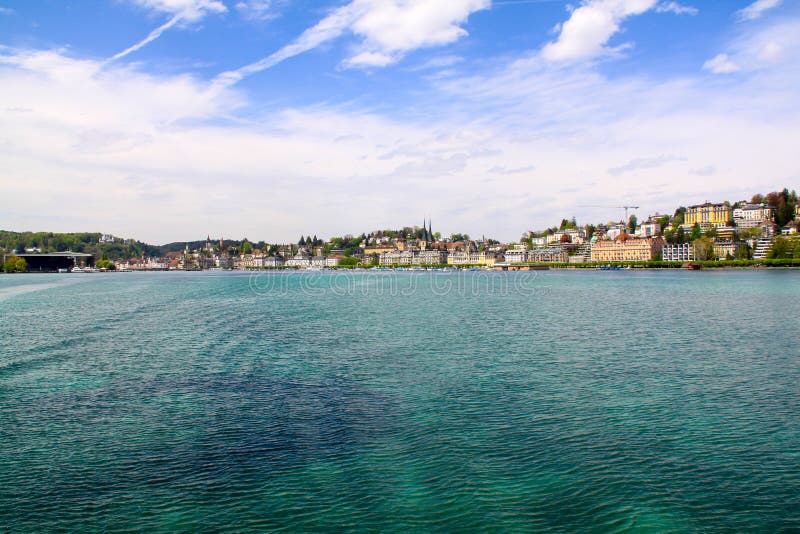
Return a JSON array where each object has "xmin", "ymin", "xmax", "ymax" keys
[{"xmin": 0, "ymin": 271, "xmax": 800, "ymax": 532}]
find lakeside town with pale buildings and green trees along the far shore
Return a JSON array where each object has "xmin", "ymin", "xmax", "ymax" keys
[{"xmin": 0, "ymin": 189, "xmax": 800, "ymax": 272}]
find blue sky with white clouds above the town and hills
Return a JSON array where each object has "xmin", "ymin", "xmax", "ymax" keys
[{"xmin": 0, "ymin": 0, "xmax": 800, "ymax": 243}]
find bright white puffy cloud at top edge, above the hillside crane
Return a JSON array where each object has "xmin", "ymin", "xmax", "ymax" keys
[{"xmin": 541, "ymin": 0, "xmax": 656, "ymax": 62}]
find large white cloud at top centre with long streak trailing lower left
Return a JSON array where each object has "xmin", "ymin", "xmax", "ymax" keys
[{"xmin": 217, "ymin": 0, "xmax": 491, "ymax": 85}]
